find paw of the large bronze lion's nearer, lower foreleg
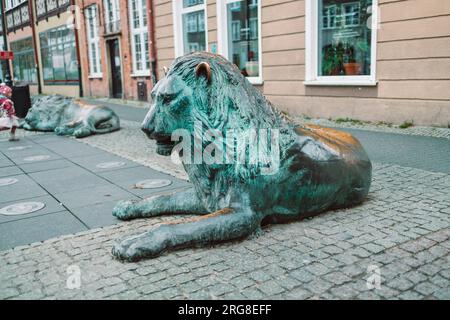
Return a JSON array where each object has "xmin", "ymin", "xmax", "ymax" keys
[{"xmin": 111, "ymin": 230, "xmax": 168, "ymax": 262}]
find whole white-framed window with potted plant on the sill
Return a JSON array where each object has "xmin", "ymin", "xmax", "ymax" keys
[{"xmin": 306, "ymin": 0, "xmax": 377, "ymax": 85}]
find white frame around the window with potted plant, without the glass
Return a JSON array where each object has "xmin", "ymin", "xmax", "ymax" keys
[{"xmin": 304, "ymin": 0, "xmax": 378, "ymax": 86}]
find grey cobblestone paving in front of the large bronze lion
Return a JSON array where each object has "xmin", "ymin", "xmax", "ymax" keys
[{"xmin": 0, "ymin": 164, "xmax": 450, "ymax": 299}]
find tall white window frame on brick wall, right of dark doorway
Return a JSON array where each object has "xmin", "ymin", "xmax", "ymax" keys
[{"xmin": 127, "ymin": 0, "xmax": 150, "ymax": 77}]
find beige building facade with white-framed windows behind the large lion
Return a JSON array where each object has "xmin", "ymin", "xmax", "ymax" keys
[{"xmin": 153, "ymin": 0, "xmax": 450, "ymax": 126}]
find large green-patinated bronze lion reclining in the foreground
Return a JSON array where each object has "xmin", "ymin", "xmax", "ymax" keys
[{"xmin": 112, "ymin": 53, "xmax": 372, "ymax": 261}]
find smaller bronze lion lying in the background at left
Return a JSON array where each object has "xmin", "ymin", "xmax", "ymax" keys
[{"xmin": 22, "ymin": 95, "xmax": 120, "ymax": 138}]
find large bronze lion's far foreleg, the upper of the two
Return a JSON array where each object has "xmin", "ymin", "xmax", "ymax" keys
[{"xmin": 113, "ymin": 188, "xmax": 208, "ymax": 220}]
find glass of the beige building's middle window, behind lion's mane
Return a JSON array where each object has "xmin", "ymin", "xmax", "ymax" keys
[{"xmin": 227, "ymin": 0, "xmax": 260, "ymax": 77}]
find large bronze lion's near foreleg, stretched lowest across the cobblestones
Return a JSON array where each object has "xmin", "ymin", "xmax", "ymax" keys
[{"xmin": 112, "ymin": 208, "xmax": 261, "ymax": 261}]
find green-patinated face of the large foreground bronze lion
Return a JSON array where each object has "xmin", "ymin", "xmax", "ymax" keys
[{"xmin": 142, "ymin": 75, "xmax": 192, "ymax": 155}]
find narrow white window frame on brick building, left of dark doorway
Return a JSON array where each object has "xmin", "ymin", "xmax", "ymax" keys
[{"xmin": 84, "ymin": 4, "xmax": 103, "ymax": 78}]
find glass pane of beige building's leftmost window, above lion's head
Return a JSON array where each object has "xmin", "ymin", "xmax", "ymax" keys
[{"xmin": 183, "ymin": 10, "xmax": 206, "ymax": 54}]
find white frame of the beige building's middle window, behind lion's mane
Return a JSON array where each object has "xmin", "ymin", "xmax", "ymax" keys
[{"xmin": 217, "ymin": 0, "xmax": 264, "ymax": 85}]
